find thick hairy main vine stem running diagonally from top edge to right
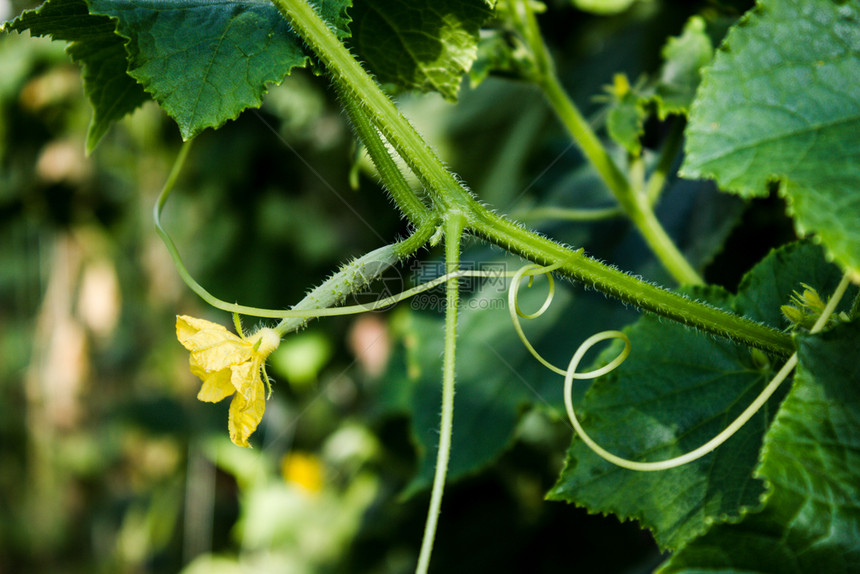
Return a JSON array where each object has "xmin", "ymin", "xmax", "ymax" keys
[{"xmin": 272, "ymin": 0, "xmax": 794, "ymax": 356}]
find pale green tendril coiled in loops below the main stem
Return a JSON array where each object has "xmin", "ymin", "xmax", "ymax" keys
[{"xmin": 508, "ymin": 265, "xmax": 851, "ymax": 472}]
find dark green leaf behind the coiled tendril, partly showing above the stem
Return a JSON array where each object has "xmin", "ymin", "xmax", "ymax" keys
[{"xmin": 549, "ymin": 243, "xmax": 839, "ymax": 548}]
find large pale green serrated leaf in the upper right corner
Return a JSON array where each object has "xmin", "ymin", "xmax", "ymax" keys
[{"xmin": 682, "ymin": 0, "xmax": 860, "ymax": 270}]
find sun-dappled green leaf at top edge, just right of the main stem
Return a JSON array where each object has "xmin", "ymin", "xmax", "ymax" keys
[{"xmin": 350, "ymin": 0, "xmax": 495, "ymax": 101}]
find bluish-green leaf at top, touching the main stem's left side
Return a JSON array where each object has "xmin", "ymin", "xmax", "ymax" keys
[{"xmin": 89, "ymin": 0, "xmax": 349, "ymax": 139}]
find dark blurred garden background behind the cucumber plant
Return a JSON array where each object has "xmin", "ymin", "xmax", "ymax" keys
[{"xmin": 0, "ymin": 0, "xmax": 770, "ymax": 574}]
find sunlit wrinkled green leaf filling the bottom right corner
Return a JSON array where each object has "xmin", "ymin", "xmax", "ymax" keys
[{"xmin": 660, "ymin": 321, "xmax": 860, "ymax": 574}]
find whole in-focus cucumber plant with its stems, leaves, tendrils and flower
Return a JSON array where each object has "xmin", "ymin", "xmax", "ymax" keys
[{"xmin": 4, "ymin": 0, "xmax": 860, "ymax": 573}]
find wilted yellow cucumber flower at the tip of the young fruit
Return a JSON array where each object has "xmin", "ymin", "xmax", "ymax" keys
[{"xmin": 176, "ymin": 315, "xmax": 281, "ymax": 448}]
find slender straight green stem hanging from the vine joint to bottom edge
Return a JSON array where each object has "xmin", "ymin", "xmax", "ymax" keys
[{"xmin": 415, "ymin": 211, "xmax": 465, "ymax": 574}]
